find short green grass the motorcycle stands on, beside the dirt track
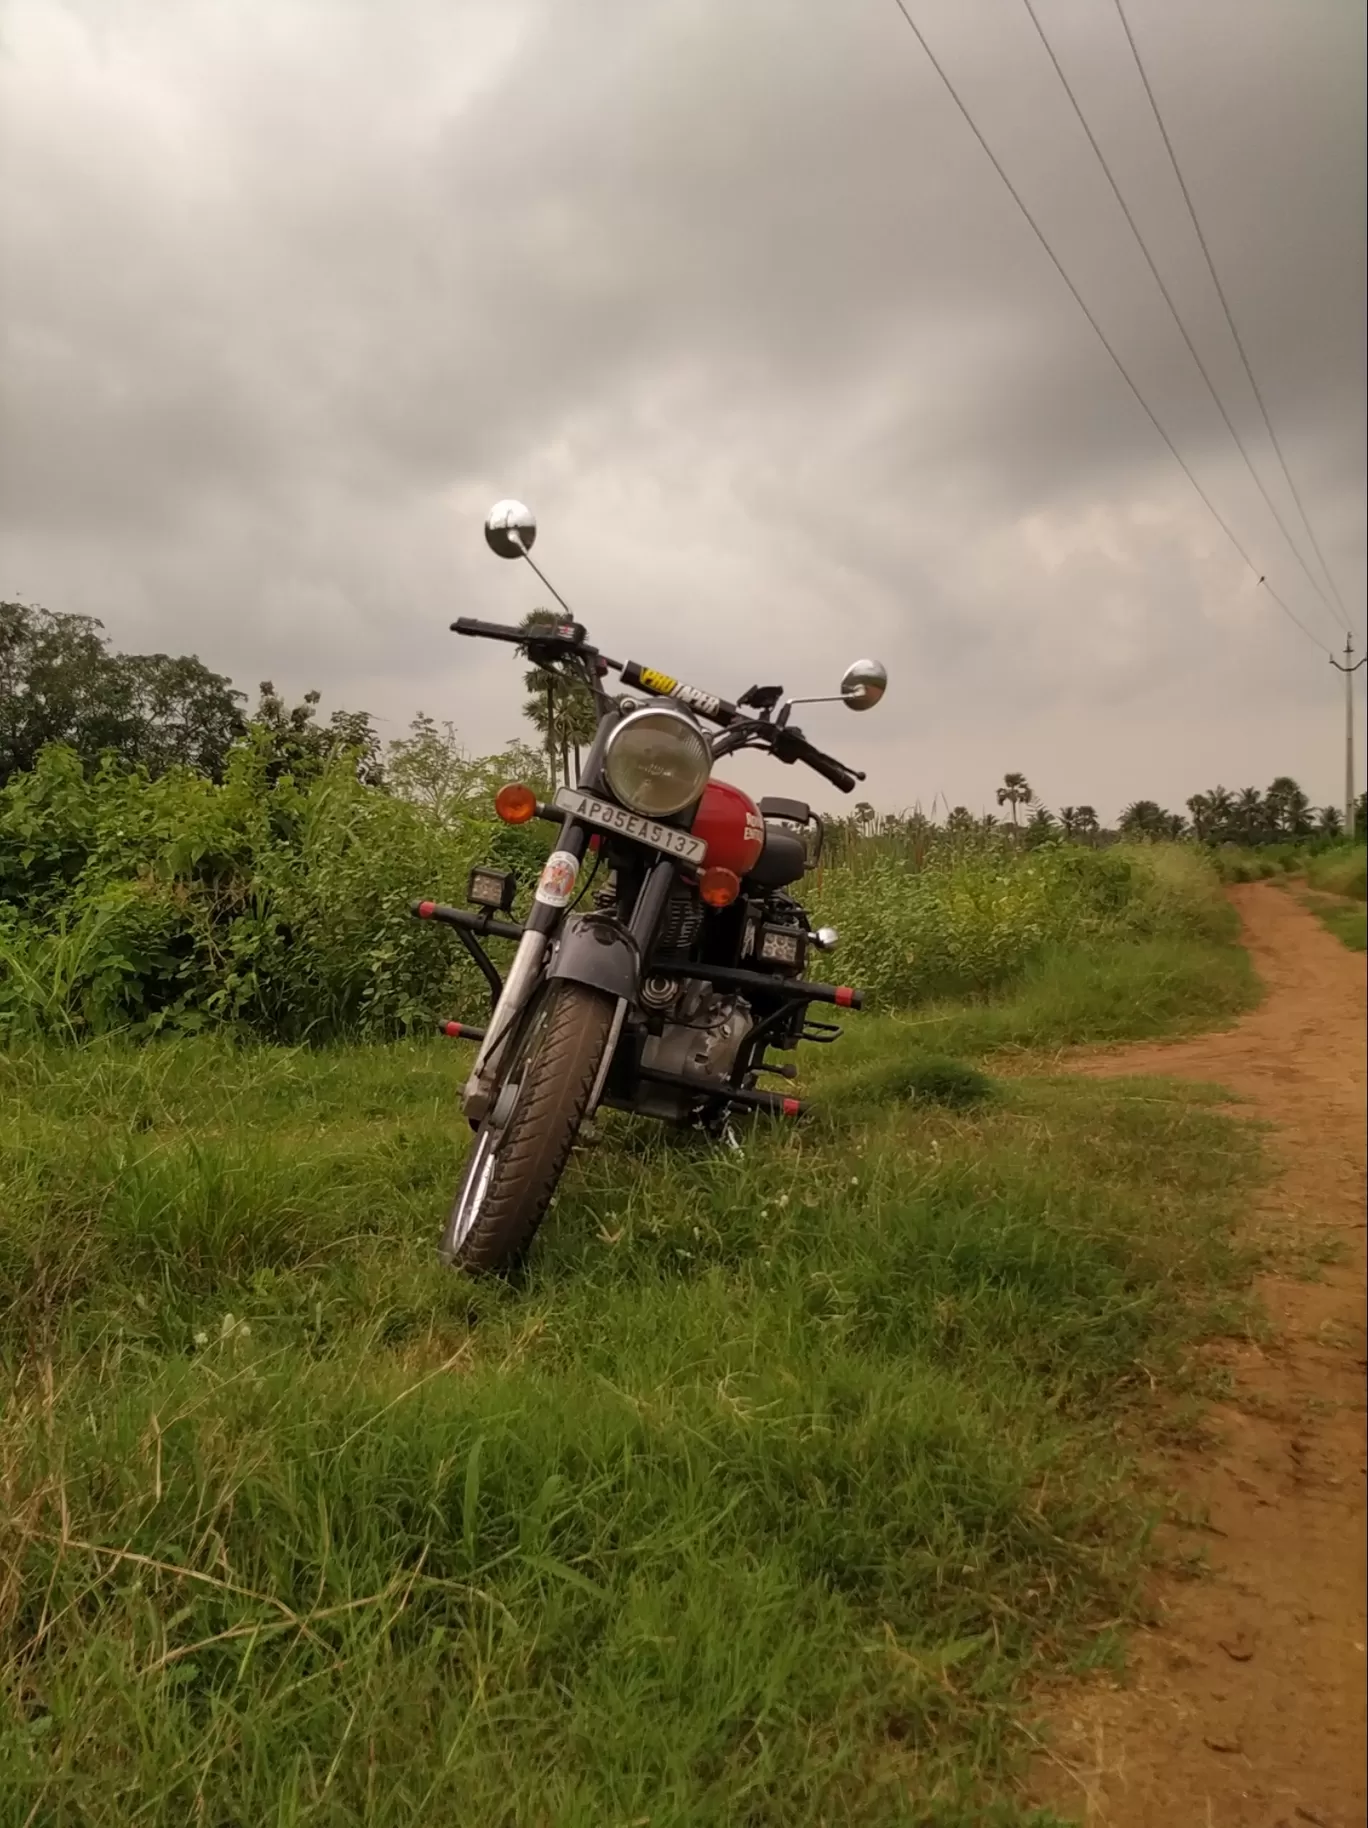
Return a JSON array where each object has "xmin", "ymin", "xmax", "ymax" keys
[{"xmin": 0, "ymin": 940, "xmax": 1255, "ymax": 1828}]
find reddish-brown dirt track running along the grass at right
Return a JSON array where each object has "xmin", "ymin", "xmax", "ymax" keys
[{"xmin": 1031, "ymin": 883, "xmax": 1368, "ymax": 1828}]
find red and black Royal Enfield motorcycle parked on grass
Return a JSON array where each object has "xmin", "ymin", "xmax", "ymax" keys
[{"xmin": 411, "ymin": 501, "xmax": 887, "ymax": 1274}]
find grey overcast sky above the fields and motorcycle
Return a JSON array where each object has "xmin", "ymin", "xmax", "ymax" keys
[{"xmin": 0, "ymin": 0, "xmax": 1364, "ymax": 815}]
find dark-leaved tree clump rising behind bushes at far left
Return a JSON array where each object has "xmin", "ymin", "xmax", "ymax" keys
[{"xmin": 0, "ymin": 603, "xmax": 243, "ymax": 781}]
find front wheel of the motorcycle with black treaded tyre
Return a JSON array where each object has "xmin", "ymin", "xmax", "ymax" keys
[{"xmin": 441, "ymin": 983, "xmax": 616, "ymax": 1274}]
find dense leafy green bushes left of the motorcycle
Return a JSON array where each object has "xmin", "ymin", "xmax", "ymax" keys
[{"xmin": 0, "ymin": 746, "xmax": 547, "ymax": 1040}]
